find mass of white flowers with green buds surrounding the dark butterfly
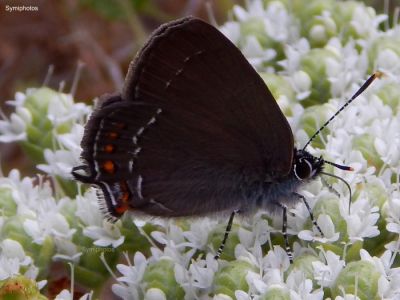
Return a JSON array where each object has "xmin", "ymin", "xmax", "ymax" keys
[{"xmin": 0, "ymin": 0, "xmax": 400, "ymax": 300}]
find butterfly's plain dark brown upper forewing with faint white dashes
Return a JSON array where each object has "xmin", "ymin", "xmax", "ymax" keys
[{"xmin": 123, "ymin": 17, "xmax": 293, "ymax": 175}]
